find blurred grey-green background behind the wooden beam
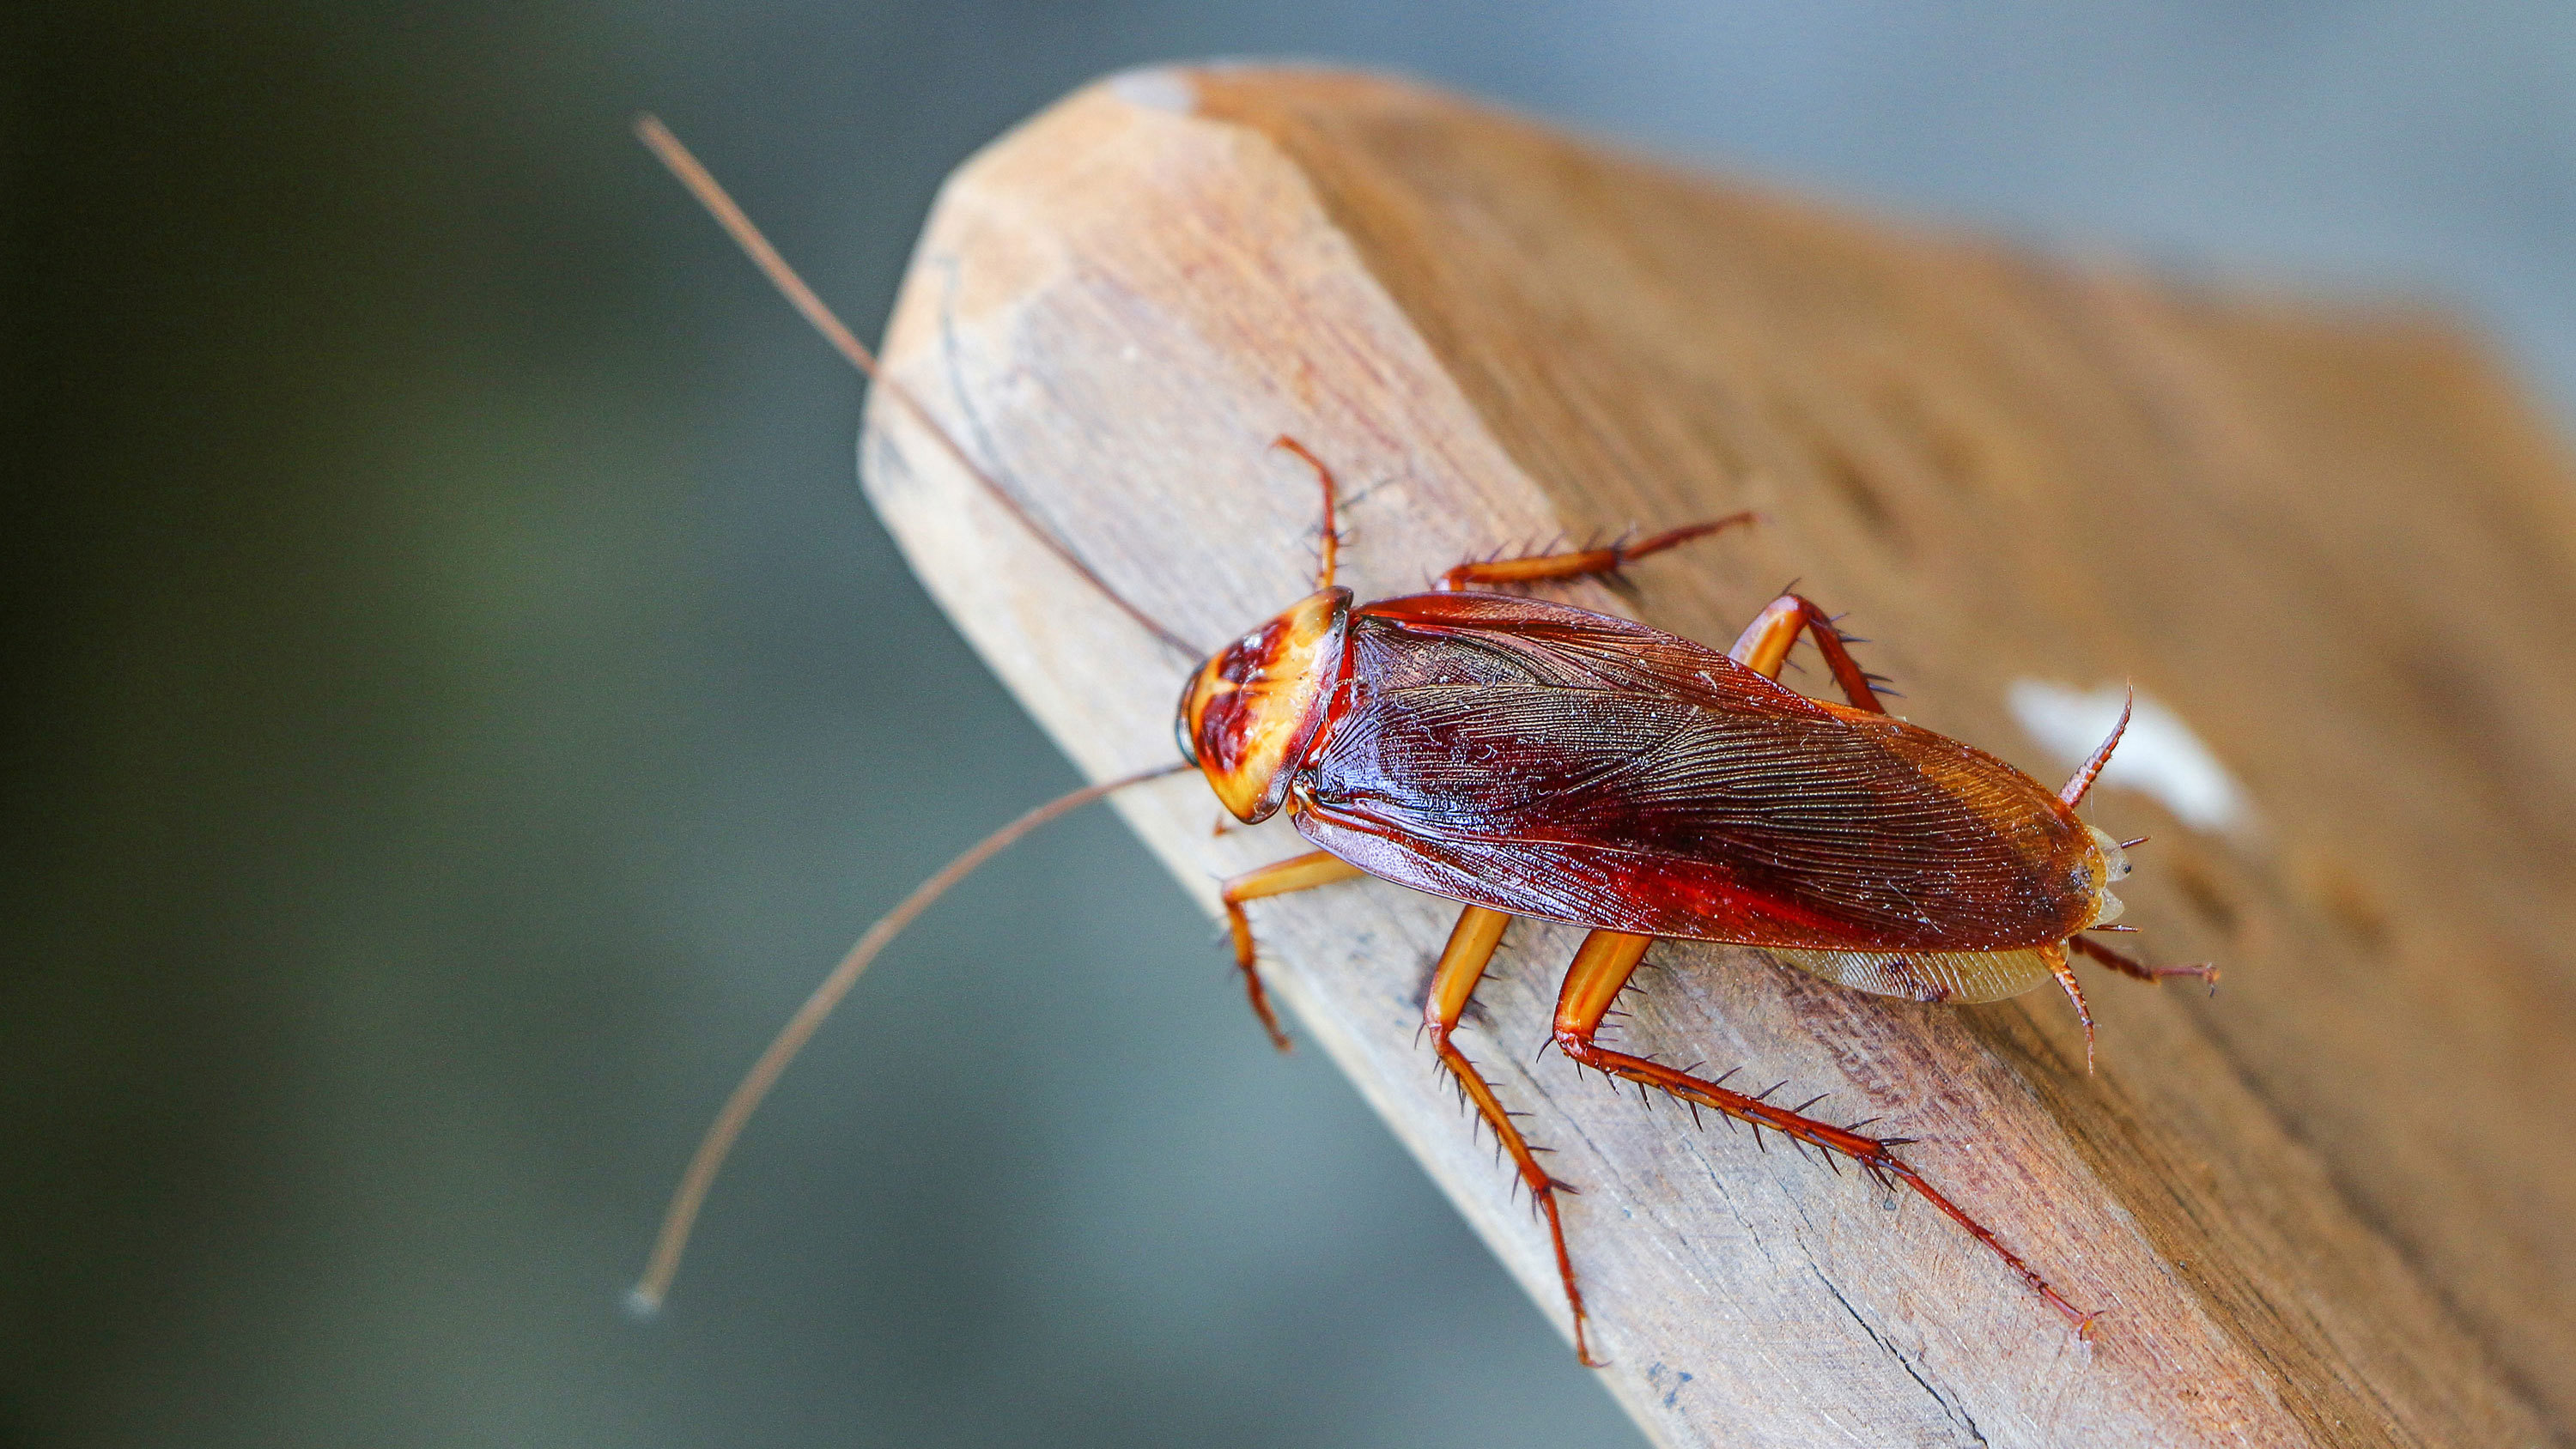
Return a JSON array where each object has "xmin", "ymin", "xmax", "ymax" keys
[{"xmin": 0, "ymin": 0, "xmax": 2576, "ymax": 1446}]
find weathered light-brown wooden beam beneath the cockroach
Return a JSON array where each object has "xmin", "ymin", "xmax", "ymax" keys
[{"xmin": 866, "ymin": 70, "xmax": 2576, "ymax": 1446}]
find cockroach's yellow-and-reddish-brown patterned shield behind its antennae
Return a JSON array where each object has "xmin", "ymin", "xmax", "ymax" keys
[{"xmin": 1172, "ymin": 590, "xmax": 1350, "ymax": 821}]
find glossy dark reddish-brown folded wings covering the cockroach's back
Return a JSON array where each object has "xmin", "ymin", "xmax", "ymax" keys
[{"xmin": 1296, "ymin": 595, "xmax": 2099, "ymax": 967}]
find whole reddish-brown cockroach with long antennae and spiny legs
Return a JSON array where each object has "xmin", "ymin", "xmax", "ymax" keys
[{"xmin": 634, "ymin": 118, "xmax": 2218, "ymax": 1364}]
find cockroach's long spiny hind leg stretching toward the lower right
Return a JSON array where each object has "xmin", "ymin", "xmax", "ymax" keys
[{"xmin": 1556, "ymin": 931, "xmax": 2094, "ymax": 1338}]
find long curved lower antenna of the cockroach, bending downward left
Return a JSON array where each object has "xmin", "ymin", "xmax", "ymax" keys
[{"xmin": 626, "ymin": 764, "xmax": 1190, "ymax": 1318}]
